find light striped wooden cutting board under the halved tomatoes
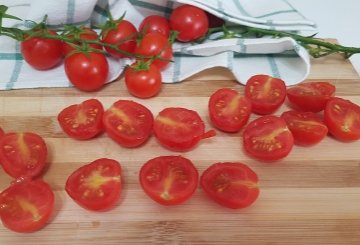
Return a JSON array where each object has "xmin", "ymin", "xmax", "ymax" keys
[{"xmin": 0, "ymin": 52, "xmax": 360, "ymax": 245}]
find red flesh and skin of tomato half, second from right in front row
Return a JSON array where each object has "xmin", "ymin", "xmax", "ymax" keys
[{"xmin": 139, "ymin": 156, "xmax": 199, "ymax": 206}]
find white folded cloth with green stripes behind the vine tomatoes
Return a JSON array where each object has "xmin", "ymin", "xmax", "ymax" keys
[{"xmin": 0, "ymin": 0, "xmax": 315, "ymax": 90}]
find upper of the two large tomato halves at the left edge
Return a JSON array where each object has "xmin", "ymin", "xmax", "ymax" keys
[{"xmin": 0, "ymin": 132, "xmax": 47, "ymax": 178}]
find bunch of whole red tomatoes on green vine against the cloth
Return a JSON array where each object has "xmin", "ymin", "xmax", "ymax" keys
[{"xmin": 21, "ymin": 5, "xmax": 209, "ymax": 98}]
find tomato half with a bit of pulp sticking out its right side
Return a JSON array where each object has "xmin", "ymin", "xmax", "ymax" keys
[{"xmin": 154, "ymin": 107, "xmax": 215, "ymax": 151}]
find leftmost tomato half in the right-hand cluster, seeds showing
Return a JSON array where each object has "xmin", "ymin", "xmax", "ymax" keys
[{"xmin": 208, "ymin": 88, "xmax": 251, "ymax": 132}]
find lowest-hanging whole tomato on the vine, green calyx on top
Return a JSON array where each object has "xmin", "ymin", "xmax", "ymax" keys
[{"xmin": 125, "ymin": 61, "xmax": 162, "ymax": 99}]
